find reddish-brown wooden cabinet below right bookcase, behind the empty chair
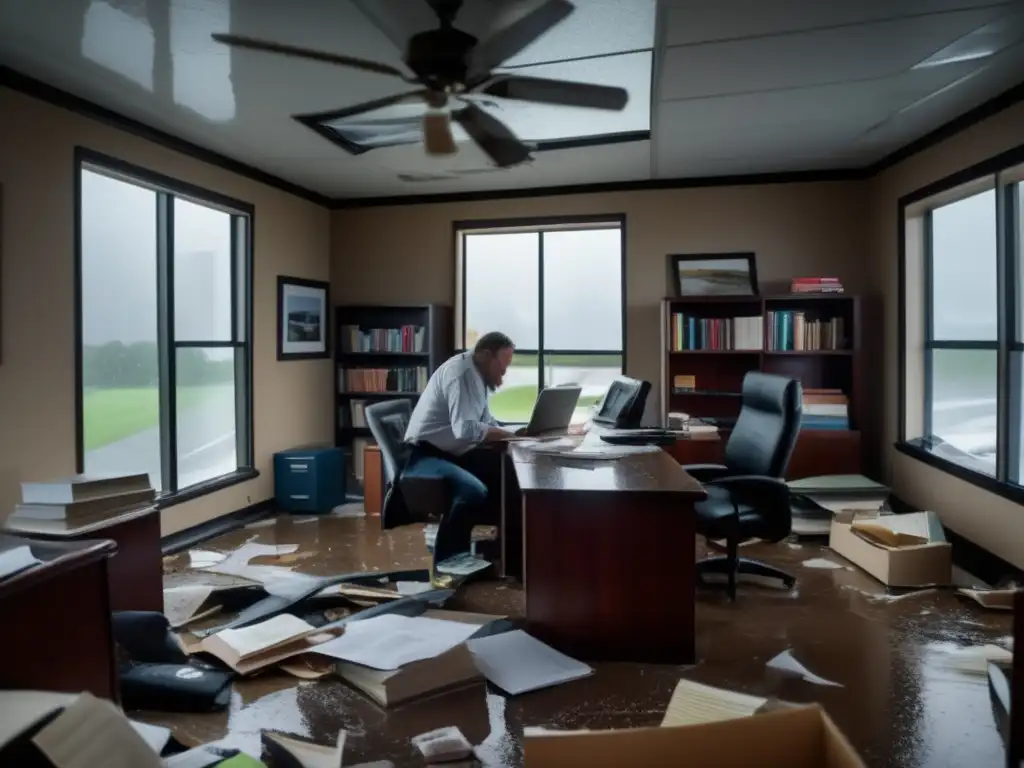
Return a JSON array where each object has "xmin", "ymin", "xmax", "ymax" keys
[{"xmin": 666, "ymin": 429, "xmax": 863, "ymax": 480}]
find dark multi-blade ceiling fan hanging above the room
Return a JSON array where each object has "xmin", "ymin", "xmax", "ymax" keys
[{"xmin": 213, "ymin": 0, "xmax": 629, "ymax": 168}]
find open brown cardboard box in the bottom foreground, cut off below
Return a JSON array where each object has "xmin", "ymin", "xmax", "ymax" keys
[{"xmin": 523, "ymin": 706, "xmax": 865, "ymax": 768}]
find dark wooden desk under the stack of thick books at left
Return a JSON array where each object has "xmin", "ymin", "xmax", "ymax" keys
[{"xmin": 7, "ymin": 507, "xmax": 164, "ymax": 612}]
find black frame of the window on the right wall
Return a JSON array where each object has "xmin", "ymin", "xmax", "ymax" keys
[{"xmin": 895, "ymin": 144, "xmax": 1024, "ymax": 504}]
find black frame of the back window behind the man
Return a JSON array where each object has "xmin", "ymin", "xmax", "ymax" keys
[{"xmin": 452, "ymin": 213, "xmax": 627, "ymax": 391}]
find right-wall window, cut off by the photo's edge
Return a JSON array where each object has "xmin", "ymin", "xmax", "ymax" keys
[{"xmin": 900, "ymin": 154, "xmax": 1024, "ymax": 498}]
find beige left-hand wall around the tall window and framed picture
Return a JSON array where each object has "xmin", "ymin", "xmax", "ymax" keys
[{"xmin": 0, "ymin": 88, "xmax": 334, "ymax": 535}]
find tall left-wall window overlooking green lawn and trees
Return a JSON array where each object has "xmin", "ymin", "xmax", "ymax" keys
[{"xmin": 78, "ymin": 152, "xmax": 253, "ymax": 500}]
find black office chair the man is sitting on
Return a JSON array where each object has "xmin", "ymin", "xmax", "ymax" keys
[{"xmin": 364, "ymin": 398, "xmax": 451, "ymax": 529}]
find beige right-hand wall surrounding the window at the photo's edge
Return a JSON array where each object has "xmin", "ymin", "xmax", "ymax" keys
[{"xmin": 870, "ymin": 103, "xmax": 1024, "ymax": 567}]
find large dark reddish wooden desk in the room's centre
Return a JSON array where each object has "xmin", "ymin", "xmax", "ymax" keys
[{"xmin": 502, "ymin": 444, "xmax": 705, "ymax": 664}]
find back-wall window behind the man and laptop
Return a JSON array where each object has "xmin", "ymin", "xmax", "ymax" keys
[{"xmin": 457, "ymin": 217, "xmax": 626, "ymax": 422}]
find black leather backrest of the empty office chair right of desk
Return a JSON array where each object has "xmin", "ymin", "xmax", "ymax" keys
[{"xmin": 725, "ymin": 372, "xmax": 803, "ymax": 477}]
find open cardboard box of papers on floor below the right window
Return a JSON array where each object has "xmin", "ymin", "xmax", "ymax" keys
[{"xmin": 828, "ymin": 510, "xmax": 952, "ymax": 588}]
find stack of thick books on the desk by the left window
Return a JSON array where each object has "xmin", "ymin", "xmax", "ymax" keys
[{"xmin": 7, "ymin": 472, "xmax": 157, "ymax": 534}]
